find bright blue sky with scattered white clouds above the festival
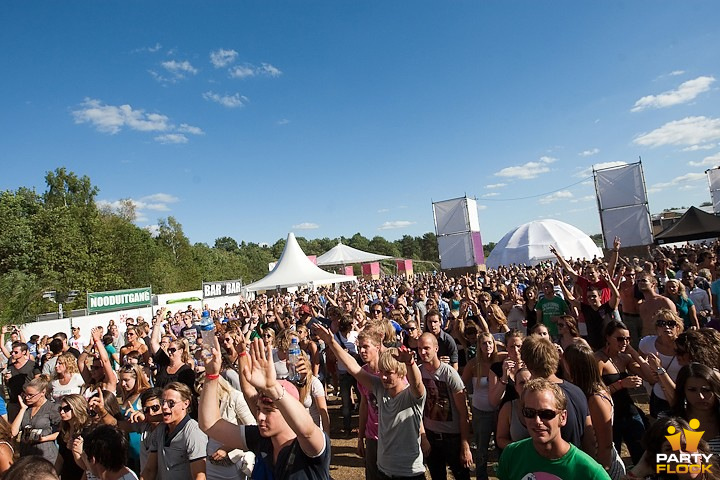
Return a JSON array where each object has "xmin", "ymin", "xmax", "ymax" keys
[{"xmin": 0, "ymin": 0, "xmax": 720, "ymax": 245}]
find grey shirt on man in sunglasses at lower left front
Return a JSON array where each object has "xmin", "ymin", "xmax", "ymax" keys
[{"xmin": 149, "ymin": 416, "xmax": 207, "ymax": 480}]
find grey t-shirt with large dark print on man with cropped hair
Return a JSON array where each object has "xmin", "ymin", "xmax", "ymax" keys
[{"xmin": 420, "ymin": 363, "xmax": 465, "ymax": 433}]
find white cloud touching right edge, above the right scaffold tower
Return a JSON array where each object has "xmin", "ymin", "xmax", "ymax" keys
[{"xmin": 633, "ymin": 116, "xmax": 720, "ymax": 147}]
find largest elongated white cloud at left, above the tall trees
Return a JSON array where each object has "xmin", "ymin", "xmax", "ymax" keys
[{"xmin": 72, "ymin": 98, "xmax": 170, "ymax": 135}]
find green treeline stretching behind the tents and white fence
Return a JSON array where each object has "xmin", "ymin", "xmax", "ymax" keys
[{"xmin": 0, "ymin": 168, "xmax": 439, "ymax": 323}]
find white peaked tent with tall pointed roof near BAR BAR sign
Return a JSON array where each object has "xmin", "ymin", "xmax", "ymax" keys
[{"xmin": 243, "ymin": 232, "xmax": 357, "ymax": 292}]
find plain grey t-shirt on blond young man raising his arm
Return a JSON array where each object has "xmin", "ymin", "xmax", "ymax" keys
[{"xmin": 372, "ymin": 377, "xmax": 427, "ymax": 477}]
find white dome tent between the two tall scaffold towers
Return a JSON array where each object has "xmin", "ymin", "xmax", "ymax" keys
[{"xmin": 486, "ymin": 220, "xmax": 603, "ymax": 268}]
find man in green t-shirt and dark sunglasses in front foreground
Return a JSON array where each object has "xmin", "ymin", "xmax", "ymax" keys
[{"xmin": 497, "ymin": 378, "xmax": 610, "ymax": 480}]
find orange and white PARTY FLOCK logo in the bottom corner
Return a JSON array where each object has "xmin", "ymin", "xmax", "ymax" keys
[{"xmin": 655, "ymin": 418, "xmax": 712, "ymax": 474}]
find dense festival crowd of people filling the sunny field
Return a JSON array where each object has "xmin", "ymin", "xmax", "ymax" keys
[{"xmin": 0, "ymin": 239, "xmax": 720, "ymax": 480}]
